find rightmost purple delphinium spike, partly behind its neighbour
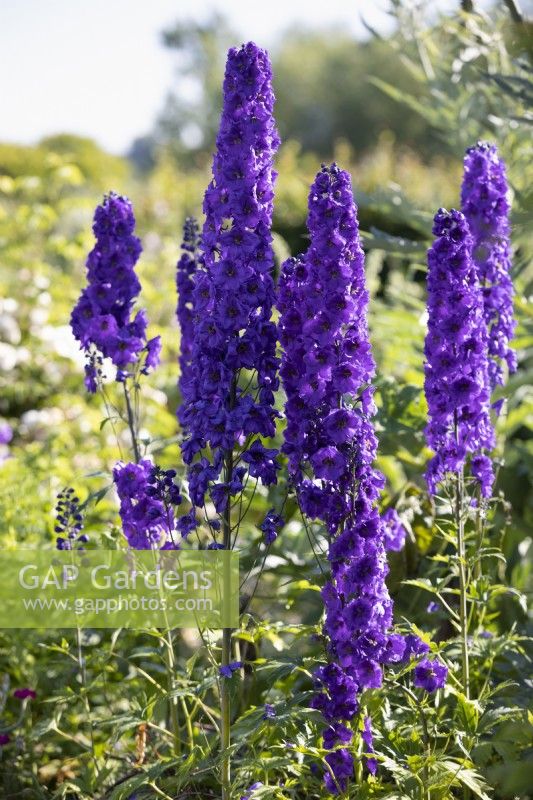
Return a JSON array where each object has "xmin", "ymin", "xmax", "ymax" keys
[{"xmin": 461, "ymin": 142, "xmax": 516, "ymax": 388}]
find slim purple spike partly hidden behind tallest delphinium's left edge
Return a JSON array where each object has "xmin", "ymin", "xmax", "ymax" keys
[{"xmin": 176, "ymin": 217, "xmax": 200, "ymax": 422}]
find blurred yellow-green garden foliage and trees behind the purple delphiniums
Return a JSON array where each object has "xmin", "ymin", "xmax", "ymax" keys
[{"xmin": 0, "ymin": 0, "xmax": 533, "ymax": 797}]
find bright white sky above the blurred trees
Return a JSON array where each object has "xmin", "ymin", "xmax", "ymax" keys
[{"xmin": 0, "ymin": 0, "xmax": 498, "ymax": 153}]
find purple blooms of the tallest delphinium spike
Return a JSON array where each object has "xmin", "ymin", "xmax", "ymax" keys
[{"xmin": 179, "ymin": 43, "xmax": 279, "ymax": 507}]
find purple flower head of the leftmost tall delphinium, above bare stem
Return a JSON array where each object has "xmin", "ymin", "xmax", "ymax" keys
[{"xmin": 70, "ymin": 193, "xmax": 161, "ymax": 392}]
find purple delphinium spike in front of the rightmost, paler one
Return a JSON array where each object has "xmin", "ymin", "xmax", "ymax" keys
[{"xmin": 424, "ymin": 208, "xmax": 494, "ymax": 497}]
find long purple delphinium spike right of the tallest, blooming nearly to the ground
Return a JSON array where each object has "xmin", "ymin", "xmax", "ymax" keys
[{"xmin": 279, "ymin": 164, "xmax": 405, "ymax": 792}]
